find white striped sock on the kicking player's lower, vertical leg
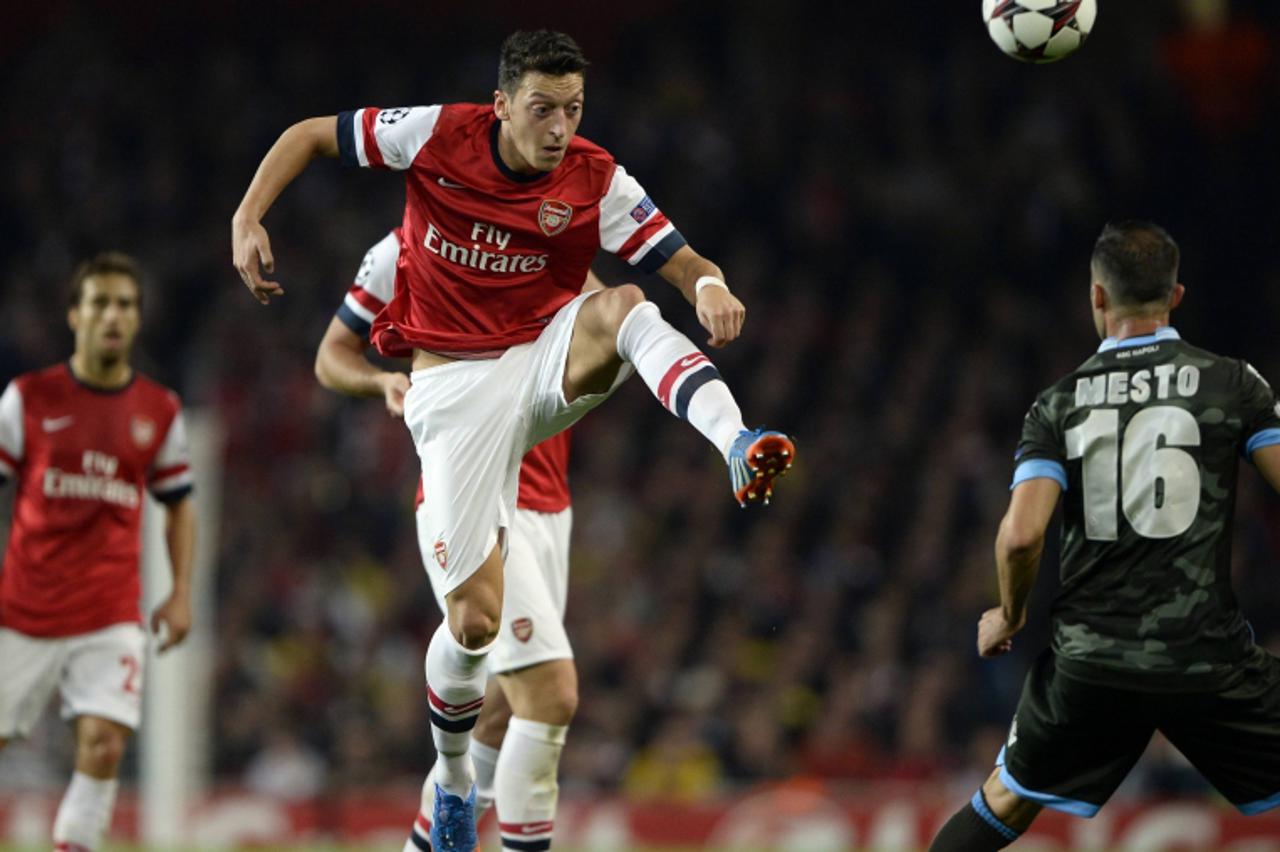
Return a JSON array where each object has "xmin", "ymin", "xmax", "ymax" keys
[{"xmin": 426, "ymin": 620, "xmax": 493, "ymax": 798}]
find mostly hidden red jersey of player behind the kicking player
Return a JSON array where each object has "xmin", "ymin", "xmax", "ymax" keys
[{"xmin": 338, "ymin": 228, "xmax": 570, "ymax": 512}]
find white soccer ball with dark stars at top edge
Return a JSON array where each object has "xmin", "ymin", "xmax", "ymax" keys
[{"xmin": 982, "ymin": 0, "xmax": 1098, "ymax": 64}]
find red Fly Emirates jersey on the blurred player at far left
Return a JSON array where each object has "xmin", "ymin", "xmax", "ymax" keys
[{"xmin": 0, "ymin": 363, "xmax": 192, "ymax": 636}]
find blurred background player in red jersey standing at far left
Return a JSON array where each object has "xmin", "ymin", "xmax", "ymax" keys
[{"xmin": 0, "ymin": 252, "xmax": 196, "ymax": 852}]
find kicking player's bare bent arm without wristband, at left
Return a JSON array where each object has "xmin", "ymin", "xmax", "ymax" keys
[{"xmin": 232, "ymin": 115, "xmax": 338, "ymax": 304}]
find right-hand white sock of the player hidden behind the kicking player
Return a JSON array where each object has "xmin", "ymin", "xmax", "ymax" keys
[{"xmin": 494, "ymin": 718, "xmax": 568, "ymax": 852}]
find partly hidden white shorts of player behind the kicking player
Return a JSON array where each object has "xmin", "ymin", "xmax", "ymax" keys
[{"xmin": 417, "ymin": 504, "xmax": 573, "ymax": 674}]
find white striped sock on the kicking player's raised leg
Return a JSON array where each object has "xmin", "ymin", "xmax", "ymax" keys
[{"xmin": 617, "ymin": 302, "xmax": 745, "ymax": 459}]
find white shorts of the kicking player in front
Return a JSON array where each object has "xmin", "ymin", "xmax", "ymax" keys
[{"xmin": 404, "ymin": 293, "xmax": 619, "ymax": 595}]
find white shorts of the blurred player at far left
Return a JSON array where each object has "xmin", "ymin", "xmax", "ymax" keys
[{"xmin": 0, "ymin": 623, "xmax": 146, "ymax": 739}]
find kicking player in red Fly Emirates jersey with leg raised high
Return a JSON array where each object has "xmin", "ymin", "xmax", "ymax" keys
[{"xmin": 232, "ymin": 31, "xmax": 795, "ymax": 852}]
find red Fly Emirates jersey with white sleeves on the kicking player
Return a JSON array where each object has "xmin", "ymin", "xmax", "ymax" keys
[{"xmin": 338, "ymin": 104, "xmax": 685, "ymax": 358}]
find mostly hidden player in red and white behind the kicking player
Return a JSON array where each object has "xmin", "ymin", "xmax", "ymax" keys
[{"xmin": 316, "ymin": 228, "xmax": 601, "ymax": 852}]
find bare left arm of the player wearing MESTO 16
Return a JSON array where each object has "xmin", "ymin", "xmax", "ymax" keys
[{"xmin": 978, "ymin": 478, "xmax": 1062, "ymax": 656}]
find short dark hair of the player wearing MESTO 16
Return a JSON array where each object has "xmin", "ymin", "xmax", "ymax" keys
[{"xmin": 1091, "ymin": 219, "xmax": 1179, "ymax": 307}]
